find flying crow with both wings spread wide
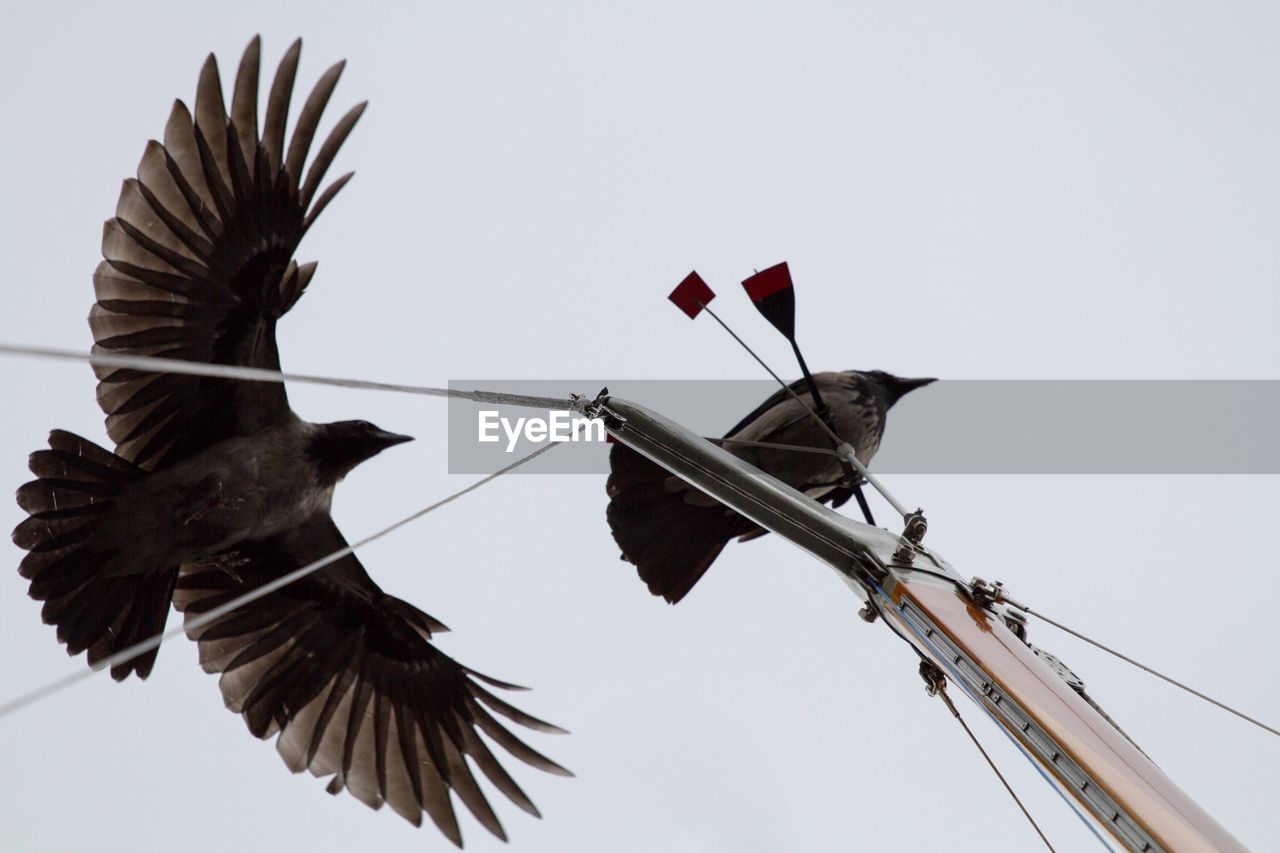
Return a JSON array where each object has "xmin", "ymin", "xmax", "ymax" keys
[{"xmin": 13, "ymin": 38, "xmax": 566, "ymax": 845}]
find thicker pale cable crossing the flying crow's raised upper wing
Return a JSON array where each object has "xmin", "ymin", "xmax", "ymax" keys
[{"xmin": 0, "ymin": 343, "xmax": 580, "ymax": 410}]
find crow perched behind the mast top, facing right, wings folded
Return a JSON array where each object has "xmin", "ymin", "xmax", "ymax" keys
[{"xmin": 605, "ymin": 370, "xmax": 933, "ymax": 605}]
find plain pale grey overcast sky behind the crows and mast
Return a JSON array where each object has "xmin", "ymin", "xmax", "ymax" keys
[{"xmin": 0, "ymin": 6, "xmax": 1280, "ymax": 853}]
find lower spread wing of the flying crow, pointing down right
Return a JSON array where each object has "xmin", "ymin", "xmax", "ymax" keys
[{"xmin": 174, "ymin": 515, "xmax": 570, "ymax": 847}]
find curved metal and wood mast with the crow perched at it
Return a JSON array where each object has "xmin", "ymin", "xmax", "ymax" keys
[{"xmin": 584, "ymin": 396, "xmax": 1245, "ymax": 850}]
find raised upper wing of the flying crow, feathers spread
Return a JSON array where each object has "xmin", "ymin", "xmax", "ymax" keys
[{"xmin": 90, "ymin": 37, "xmax": 365, "ymax": 470}]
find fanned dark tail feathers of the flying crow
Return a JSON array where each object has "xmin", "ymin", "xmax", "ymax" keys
[{"xmin": 13, "ymin": 430, "xmax": 178, "ymax": 681}]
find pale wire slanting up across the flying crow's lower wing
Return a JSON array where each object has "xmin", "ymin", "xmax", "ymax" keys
[{"xmin": 0, "ymin": 443, "xmax": 557, "ymax": 717}]
